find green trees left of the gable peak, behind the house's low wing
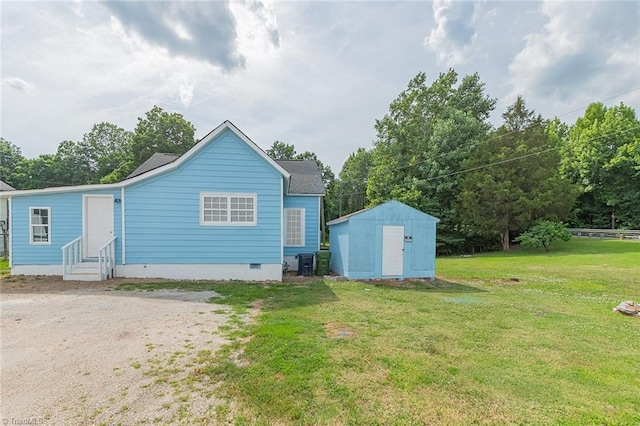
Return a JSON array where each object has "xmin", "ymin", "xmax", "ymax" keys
[{"xmin": 0, "ymin": 106, "xmax": 196, "ymax": 189}]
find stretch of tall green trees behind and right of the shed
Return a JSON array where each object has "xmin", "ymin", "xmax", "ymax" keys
[{"xmin": 337, "ymin": 70, "xmax": 640, "ymax": 253}]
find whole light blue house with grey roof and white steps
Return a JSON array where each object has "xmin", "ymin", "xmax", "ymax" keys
[{"xmin": 9, "ymin": 121, "xmax": 324, "ymax": 281}]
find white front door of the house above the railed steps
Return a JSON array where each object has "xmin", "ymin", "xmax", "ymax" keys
[{"xmin": 84, "ymin": 195, "xmax": 113, "ymax": 257}]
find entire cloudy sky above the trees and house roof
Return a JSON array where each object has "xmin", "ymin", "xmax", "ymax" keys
[{"xmin": 0, "ymin": 0, "xmax": 640, "ymax": 174}]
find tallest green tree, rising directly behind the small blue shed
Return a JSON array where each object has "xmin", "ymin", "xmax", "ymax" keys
[{"xmin": 367, "ymin": 70, "xmax": 495, "ymax": 252}]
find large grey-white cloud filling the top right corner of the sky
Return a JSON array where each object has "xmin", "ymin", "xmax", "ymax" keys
[{"xmin": 509, "ymin": 1, "xmax": 640, "ymax": 113}]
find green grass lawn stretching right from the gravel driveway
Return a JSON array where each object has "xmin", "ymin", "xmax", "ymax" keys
[{"xmin": 116, "ymin": 239, "xmax": 640, "ymax": 425}]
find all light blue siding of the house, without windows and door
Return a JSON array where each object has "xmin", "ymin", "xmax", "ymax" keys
[{"xmin": 11, "ymin": 123, "xmax": 328, "ymax": 272}]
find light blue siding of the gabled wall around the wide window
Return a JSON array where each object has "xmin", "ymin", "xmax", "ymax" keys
[{"xmin": 124, "ymin": 130, "xmax": 283, "ymax": 264}]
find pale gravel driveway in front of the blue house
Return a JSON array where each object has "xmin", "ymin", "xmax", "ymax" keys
[{"xmin": 0, "ymin": 278, "xmax": 235, "ymax": 424}]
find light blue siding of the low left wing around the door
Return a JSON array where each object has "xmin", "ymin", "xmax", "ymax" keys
[{"xmin": 11, "ymin": 189, "xmax": 122, "ymax": 265}]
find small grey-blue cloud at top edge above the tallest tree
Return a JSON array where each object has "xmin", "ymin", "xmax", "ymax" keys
[{"xmin": 424, "ymin": 0, "xmax": 476, "ymax": 66}]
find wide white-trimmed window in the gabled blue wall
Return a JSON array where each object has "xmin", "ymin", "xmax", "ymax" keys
[{"xmin": 200, "ymin": 193, "xmax": 257, "ymax": 226}]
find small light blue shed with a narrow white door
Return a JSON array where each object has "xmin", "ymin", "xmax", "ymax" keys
[{"xmin": 327, "ymin": 201, "xmax": 439, "ymax": 279}]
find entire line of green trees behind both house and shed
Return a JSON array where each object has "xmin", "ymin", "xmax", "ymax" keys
[{"xmin": 0, "ymin": 69, "xmax": 640, "ymax": 253}]
